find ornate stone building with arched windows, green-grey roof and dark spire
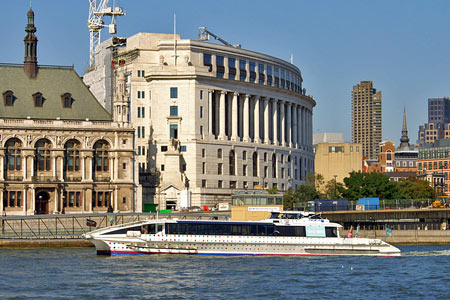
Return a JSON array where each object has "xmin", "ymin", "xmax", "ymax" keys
[{"xmin": 0, "ymin": 9, "xmax": 136, "ymax": 215}]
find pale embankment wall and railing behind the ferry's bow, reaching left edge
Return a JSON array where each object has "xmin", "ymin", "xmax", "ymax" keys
[{"xmin": 0, "ymin": 213, "xmax": 229, "ymax": 240}]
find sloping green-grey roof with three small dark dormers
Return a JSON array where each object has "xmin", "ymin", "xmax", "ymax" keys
[{"xmin": 0, "ymin": 65, "xmax": 112, "ymax": 121}]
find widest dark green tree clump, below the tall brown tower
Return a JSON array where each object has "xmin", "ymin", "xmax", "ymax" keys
[{"xmin": 338, "ymin": 171, "xmax": 397, "ymax": 200}]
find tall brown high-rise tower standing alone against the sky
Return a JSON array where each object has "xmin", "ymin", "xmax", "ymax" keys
[{"xmin": 352, "ymin": 81, "xmax": 382, "ymax": 159}]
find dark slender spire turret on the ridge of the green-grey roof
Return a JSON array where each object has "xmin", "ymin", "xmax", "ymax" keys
[{"xmin": 23, "ymin": 3, "xmax": 38, "ymax": 78}]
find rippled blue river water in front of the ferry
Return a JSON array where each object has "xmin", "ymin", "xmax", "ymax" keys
[{"xmin": 0, "ymin": 245, "xmax": 450, "ymax": 300}]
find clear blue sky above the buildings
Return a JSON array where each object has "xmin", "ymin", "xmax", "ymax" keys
[{"xmin": 0, "ymin": 0, "xmax": 450, "ymax": 145}]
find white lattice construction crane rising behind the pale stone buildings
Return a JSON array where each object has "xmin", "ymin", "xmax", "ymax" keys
[{"xmin": 88, "ymin": 0, "xmax": 125, "ymax": 69}]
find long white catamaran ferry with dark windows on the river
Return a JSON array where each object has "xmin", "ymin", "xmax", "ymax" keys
[{"xmin": 84, "ymin": 211, "xmax": 400, "ymax": 256}]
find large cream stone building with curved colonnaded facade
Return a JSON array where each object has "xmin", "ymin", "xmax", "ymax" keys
[{"xmin": 85, "ymin": 33, "xmax": 316, "ymax": 208}]
